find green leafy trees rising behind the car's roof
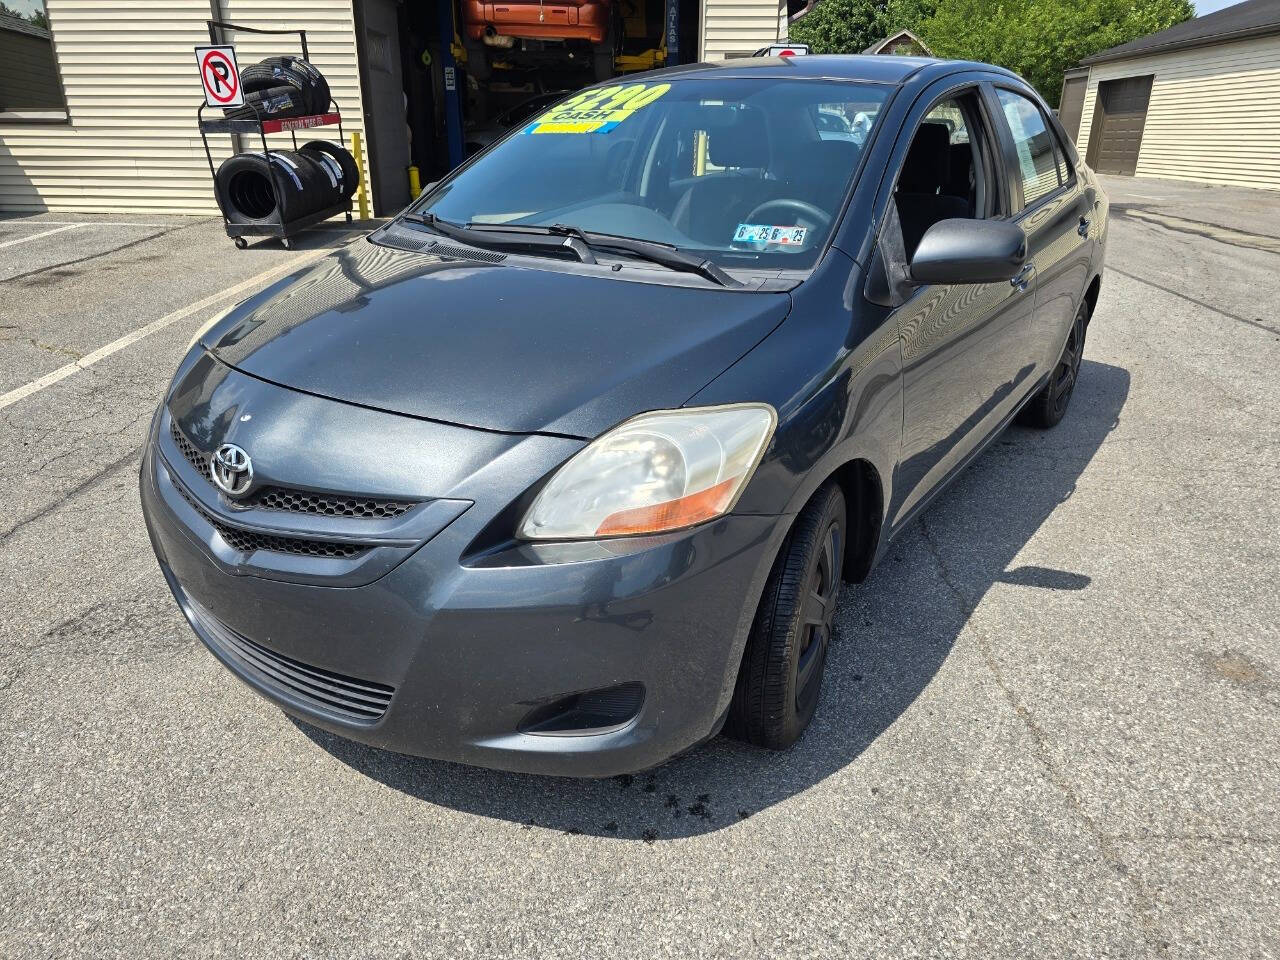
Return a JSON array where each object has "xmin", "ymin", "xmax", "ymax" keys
[{"xmin": 791, "ymin": 0, "xmax": 1196, "ymax": 105}]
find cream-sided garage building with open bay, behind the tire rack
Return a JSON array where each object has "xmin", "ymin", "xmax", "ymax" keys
[{"xmin": 0, "ymin": 0, "xmax": 787, "ymax": 215}]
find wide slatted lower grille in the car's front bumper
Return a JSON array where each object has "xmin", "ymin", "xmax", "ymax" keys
[{"xmin": 187, "ymin": 596, "xmax": 396, "ymax": 724}]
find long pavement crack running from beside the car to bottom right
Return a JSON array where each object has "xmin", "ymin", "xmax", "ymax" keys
[{"xmin": 918, "ymin": 517, "xmax": 1169, "ymax": 950}]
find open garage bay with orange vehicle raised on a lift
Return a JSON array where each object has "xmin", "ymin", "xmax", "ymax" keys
[{"xmin": 355, "ymin": 0, "xmax": 699, "ymax": 215}]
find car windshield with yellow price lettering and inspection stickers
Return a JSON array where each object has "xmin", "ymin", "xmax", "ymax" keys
[{"xmin": 413, "ymin": 78, "xmax": 888, "ymax": 270}]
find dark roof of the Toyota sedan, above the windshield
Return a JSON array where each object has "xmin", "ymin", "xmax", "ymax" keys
[{"xmin": 634, "ymin": 54, "xmax": 1016, "ymax": 86}]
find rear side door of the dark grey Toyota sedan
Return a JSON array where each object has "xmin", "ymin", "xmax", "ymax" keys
[{"xmin": 991, "ymin": 86, "xmax": 1094, "ymax": 380}]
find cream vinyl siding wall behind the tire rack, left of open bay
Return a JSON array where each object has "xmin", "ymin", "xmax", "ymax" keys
[{"xmin": 0, "ymin": 0, "xmax": 371, "ymax": 215}]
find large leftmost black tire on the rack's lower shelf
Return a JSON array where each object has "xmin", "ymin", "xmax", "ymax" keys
[{"xmin": 215, "ymin": 150, "xmax": 333, "ymax": 224}]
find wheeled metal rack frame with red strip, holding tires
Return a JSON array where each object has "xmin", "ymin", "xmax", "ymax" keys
[{"xmin": 196, "ymin": 20, "xmax": 351, "ymax": 250}]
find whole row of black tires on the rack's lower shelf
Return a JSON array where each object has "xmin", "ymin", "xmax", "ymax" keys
[{"xmin": 215, "ymin": 140, "xmax": 360, "ymax": 224}]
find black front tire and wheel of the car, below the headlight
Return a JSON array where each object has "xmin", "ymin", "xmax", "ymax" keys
[{"xmin": 724, "ymin": 483, "xmax": 847, "ymax": 750}]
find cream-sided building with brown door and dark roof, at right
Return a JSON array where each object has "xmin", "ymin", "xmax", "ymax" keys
[{"xmin": 1059, "ymin": 0, "xmax": 1280, "ymax": 189}]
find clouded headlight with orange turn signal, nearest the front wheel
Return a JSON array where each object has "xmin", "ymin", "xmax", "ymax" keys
[{"xmin": 520, "ymin": 403, "xmax": 778, "ymax": 540}]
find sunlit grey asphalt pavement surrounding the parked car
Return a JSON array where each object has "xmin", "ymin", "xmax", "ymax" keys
[{"xmin": 0, "ymin": 179, "xmax": 1280, "ymax": 957}]
